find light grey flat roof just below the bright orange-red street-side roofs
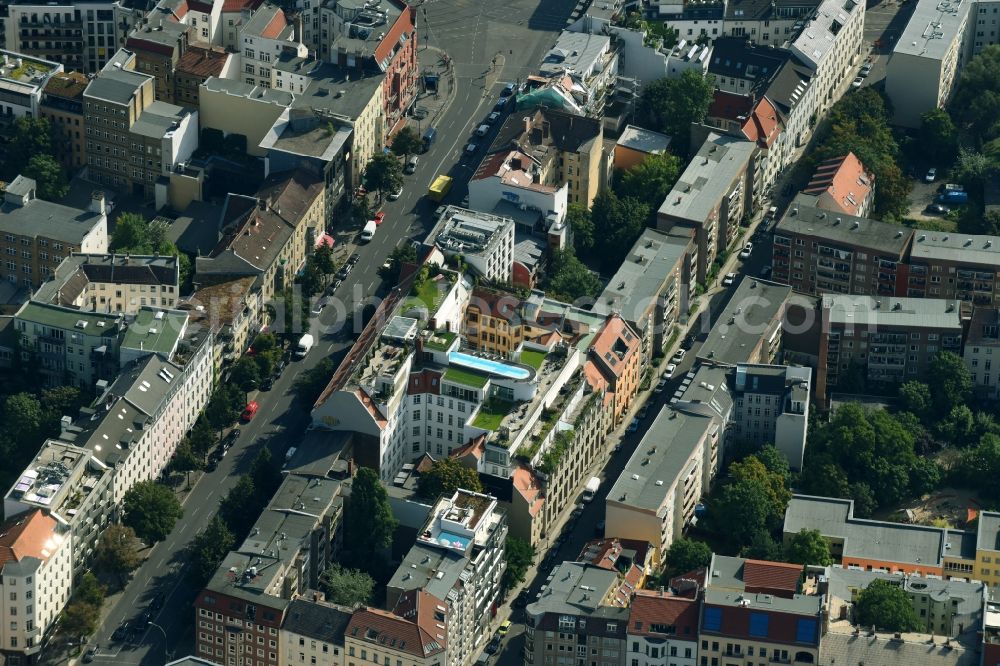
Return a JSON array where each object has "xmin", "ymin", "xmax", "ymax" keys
[{"xmin": 658, "ymin": 132, "xmax": 757, "ymax": 223}]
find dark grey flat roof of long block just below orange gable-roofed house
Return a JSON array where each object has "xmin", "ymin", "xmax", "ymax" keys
[{"xmin": 774, "ymin": 194, "xmax": 913, "ymax": 256}]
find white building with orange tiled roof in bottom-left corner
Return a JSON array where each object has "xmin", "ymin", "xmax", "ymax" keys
[{"xmin": 0, "ymin": 509, "xmax": 73, "ymax": 664}]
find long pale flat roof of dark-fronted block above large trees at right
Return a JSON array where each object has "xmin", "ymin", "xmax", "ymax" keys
[{"xmin": 822, "ymin": 294, "xmax": 962, "ymax": 332}]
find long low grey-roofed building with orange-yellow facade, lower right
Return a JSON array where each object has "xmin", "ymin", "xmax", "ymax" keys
[{"xmin": 782, "ymin": 495, "xmax": 1000, "ymax": 586}]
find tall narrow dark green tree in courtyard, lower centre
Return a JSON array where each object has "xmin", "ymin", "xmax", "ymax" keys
[{"xmin": 344, "ymin": 467, "xmax": 398, "ymax": 562}]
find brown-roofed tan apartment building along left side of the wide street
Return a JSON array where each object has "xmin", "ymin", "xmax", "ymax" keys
[{"xmin": 195, "ymin": 171, "xmax": 326, "ymax": 303}]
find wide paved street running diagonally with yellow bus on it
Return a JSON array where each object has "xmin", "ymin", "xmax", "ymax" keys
[{"xmin": 60, "ymin": 0, "xmax": 580, "ymax": 665}]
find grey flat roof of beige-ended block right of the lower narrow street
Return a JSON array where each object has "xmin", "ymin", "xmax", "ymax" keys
[{"xmin": 608, "ymin": 407, "xmax": 718, "ymax": 512}]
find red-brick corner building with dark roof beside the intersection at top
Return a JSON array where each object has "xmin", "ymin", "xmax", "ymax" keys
[{"xmin": 298, "ymin": 0, "xmax": 417, "ymax": 135}]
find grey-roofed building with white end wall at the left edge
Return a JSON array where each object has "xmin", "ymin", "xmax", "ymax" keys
[{"xmin": 0, "ymin": 176, "xmax": 108, "ymax": 290}]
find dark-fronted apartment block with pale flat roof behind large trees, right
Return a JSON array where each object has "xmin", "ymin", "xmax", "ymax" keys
[{"xmin": 816, "ymin": 294, "xmax": 962, "ymax": 400}]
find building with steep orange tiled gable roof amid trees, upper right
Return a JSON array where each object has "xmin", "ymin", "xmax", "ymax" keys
[{"xmin": 800, "ymin": 153, "xmax": 875, "ymax": 217}]
